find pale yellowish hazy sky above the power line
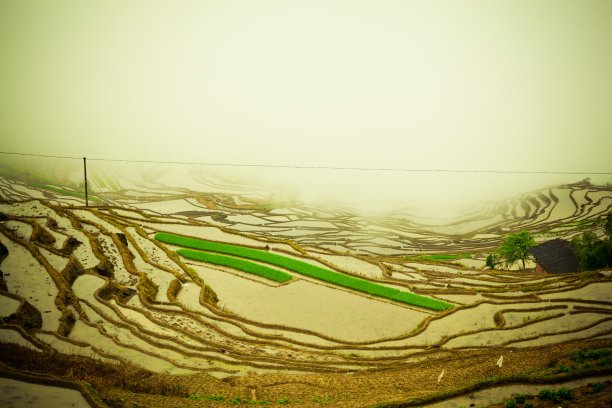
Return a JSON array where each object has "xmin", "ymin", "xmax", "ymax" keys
[{"xmin": 0, "ymin": 0, "xmax": 612, "ymax": 198}]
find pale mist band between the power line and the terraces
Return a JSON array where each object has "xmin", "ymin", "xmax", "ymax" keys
[{"xmin": 0, "ymin": 150, "xmax": 612, "ymax": 221}]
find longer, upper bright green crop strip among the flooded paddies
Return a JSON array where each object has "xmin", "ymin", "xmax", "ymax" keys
[{"xmin": 155, "ymin": 232, "xmax": 453, "ymax": 310}]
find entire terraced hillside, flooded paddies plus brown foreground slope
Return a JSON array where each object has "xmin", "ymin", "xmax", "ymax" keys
[{"xmin": 0, "ymin": 176, "xmax": 612, "ymax": 407}]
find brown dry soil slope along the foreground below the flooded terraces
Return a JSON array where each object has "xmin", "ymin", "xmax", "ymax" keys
[{"xmin": 0, "ymin": 339, "xmax": 612, "ymax": 408}]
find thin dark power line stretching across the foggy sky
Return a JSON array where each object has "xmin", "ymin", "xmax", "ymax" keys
[{"xmin": 0, "ymin": 152, "xmax": 612, "ymax": 175}]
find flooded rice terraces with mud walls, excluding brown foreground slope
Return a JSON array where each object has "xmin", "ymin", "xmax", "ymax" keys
[{"xmin": 0, "ymin": 179, "xmax": 612, "ymax": 408}]
